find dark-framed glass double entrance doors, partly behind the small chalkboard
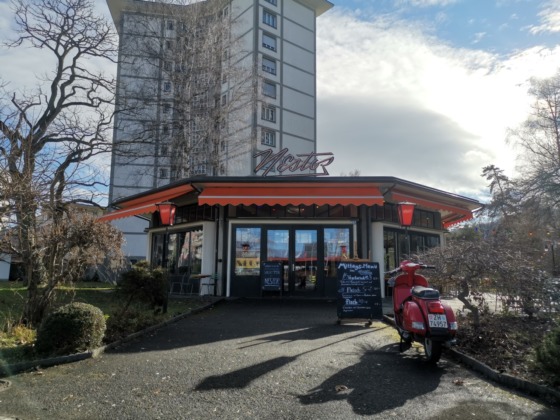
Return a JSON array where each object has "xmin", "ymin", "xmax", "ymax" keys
[{"xmin": 266, "ymin": 227, "xmax": 323, "ymax": 296}]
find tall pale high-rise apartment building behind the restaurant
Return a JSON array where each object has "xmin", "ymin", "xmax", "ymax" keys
[{"xmin": 107, "ymin": 0, "xmax": 332, "ymax": 202}]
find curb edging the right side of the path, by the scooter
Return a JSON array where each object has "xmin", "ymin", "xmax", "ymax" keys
[{"xmin": 383, "ymin": 315, "xmax": 560, "ymax": 404}]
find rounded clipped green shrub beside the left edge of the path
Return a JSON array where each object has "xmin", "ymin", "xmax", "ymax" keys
[{"xmin": 35, "ymin": 302, "xmax": 106, "ymax": 356}]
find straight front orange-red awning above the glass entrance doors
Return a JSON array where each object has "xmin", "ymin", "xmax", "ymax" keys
[{"xmin": 198, "ymin": 184, "xmax": 384, "ymax": 206}]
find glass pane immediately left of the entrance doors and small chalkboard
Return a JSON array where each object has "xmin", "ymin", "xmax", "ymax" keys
[{"xmin": 235, "ymin": 227, "xmax": 261, "ymax": 276}]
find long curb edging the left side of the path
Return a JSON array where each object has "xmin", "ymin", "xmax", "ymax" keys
[{"xmin": 0, "ymin": 298, "xmax": 225, "ymax": 378}]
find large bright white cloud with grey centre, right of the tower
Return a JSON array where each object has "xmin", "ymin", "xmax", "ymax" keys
[{"xmin": 317, "ymin": 11, "xmax": 560, "ymax": 198}]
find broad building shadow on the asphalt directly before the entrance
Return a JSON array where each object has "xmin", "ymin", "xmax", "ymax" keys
[{"xmin": 107, "ymin": 299, "xmax": 373, "ymax": 353}]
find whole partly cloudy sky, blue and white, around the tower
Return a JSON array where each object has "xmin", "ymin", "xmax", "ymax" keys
[{"xmin": 0, "ymin": 0, "xmax": 560, "ymax": 201}]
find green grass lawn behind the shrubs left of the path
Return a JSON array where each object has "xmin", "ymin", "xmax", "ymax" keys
[{"xmin": 0, "ymin": 281, "xmax": 208, "ymax": 363}]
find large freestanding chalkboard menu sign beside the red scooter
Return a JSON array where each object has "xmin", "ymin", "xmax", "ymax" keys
[{"xmin": 337, "ymin": 261, "xmax": 383, "ymax": 321}]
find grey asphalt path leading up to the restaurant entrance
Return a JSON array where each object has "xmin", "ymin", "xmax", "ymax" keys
[{"xmin": 0, "ymin": 300, "xmax": 560, "ymax": 420}]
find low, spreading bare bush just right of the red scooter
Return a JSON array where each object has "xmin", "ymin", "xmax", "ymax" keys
[{"xmin": 420, "ymin": 235, "xmax": 546, "ymax": 327}]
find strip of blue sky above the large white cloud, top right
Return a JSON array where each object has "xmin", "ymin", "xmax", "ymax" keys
[{"xmin": 333, "ymin": 0, "xmax": 559, "ymax": 54}]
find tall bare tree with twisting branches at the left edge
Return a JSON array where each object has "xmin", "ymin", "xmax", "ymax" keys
[{"xmin": 0, "ymin": 0, "xmax": 122, "ymax": 324}]
